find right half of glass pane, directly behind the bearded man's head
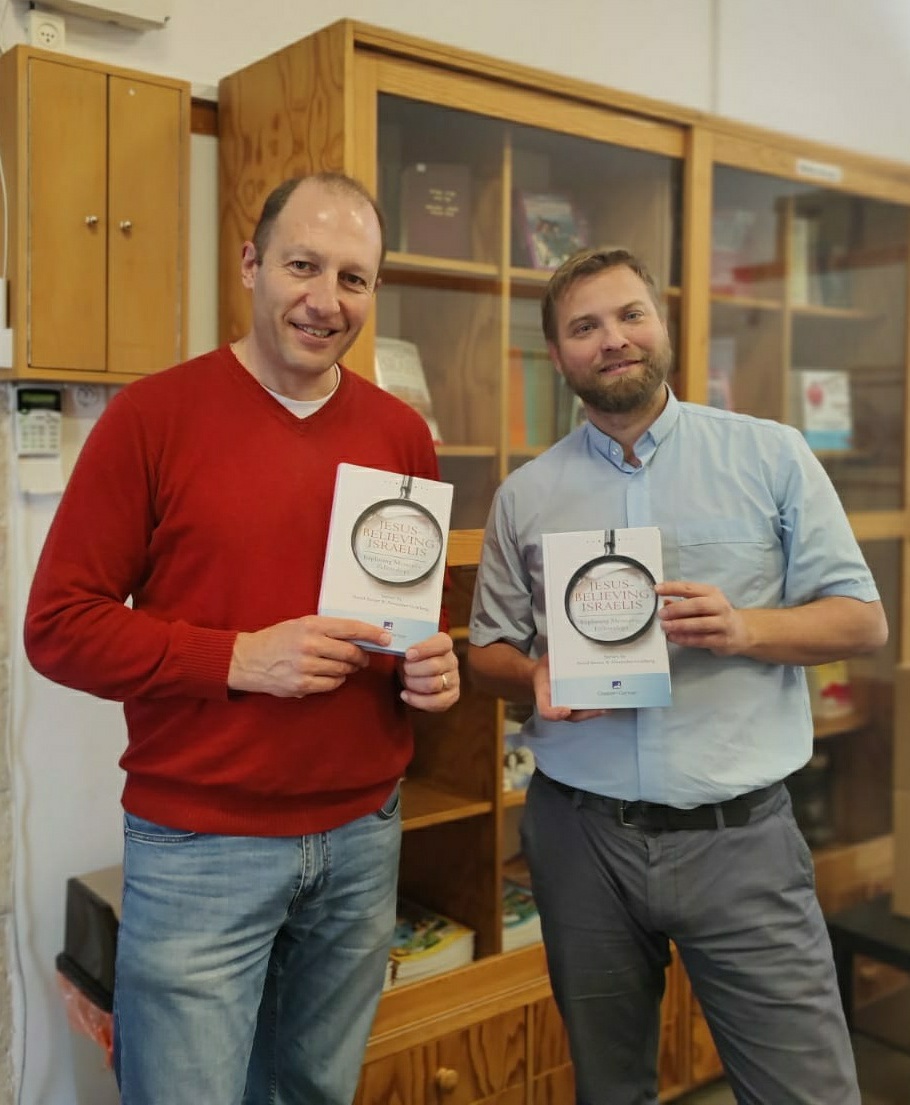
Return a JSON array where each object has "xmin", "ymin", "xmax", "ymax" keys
[{"xmin": 504, "ymin": 127, "xmax": 681, "ymax": 469}]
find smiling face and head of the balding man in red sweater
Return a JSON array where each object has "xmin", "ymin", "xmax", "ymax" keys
[{"xmin": 235, "ymin": 180, "xmax": 382, "ymax": 399}]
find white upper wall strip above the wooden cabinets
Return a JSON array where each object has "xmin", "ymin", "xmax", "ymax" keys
[{"xmin": 0, "ymin": 0, "xmax": 910, "ymax": 161}]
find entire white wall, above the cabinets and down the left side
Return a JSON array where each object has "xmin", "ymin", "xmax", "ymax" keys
[{"xmin": 0, "ymin": 0, "xmax": 910, "ymax": 1105}]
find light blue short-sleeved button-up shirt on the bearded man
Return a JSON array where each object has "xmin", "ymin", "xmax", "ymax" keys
[{"xmin": 470, "ymin": 393, "xmax": 878, "ymax": 807}]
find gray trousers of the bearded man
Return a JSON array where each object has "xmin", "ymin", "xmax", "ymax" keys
[{"xmin": 521, "ymin": 776, "xmax": 860, "ymax": 1105}]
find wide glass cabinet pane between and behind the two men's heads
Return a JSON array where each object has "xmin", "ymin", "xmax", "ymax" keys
[{"xmin": 375, "ymin": 92, "xmax": 681, "ymax": 529}]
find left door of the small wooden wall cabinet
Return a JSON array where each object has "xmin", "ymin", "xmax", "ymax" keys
[{"xmin": 28, "ymin": 59, "xmax": 107, "ymax": 371}]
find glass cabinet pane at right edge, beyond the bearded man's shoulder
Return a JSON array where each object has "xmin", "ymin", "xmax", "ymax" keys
[{"xmin": 708, "ymin": 166, "xmax": 908, "ymax": 512}]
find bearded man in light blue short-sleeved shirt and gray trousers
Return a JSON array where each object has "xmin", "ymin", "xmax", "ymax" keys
[{"xmin": 469, "ymin": 250, "xmax": 887, "ymax": 1105}]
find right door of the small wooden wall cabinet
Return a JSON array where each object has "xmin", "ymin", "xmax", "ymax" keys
[{"xmin": 107, "ymin": 76, "xmax": 184, "ymax": 372}]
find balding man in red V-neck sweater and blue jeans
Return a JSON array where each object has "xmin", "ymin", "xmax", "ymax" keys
[{"xmin": 25, "ymin": 175, "xmax": 458, "ymax": 1105}]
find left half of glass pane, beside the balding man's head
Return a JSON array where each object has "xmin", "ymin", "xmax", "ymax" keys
[{"xmin": 375, "ymin": 95, "xmax": 504, "ymax": 529}]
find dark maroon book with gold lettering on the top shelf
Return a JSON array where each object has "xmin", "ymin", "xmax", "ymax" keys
[{"xmin": 401, "ymin": 161, "xmax": 472, "ymax": 261}]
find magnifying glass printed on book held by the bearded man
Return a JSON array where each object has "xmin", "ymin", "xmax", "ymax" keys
[{"xmin": 565, "ymin": 529, "xmax": 657, "ymax": 644}]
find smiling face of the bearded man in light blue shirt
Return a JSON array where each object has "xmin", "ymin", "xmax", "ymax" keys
[{"xmin": 548, "ymin": 264, "xmax": 673, "ymax": 421}]
